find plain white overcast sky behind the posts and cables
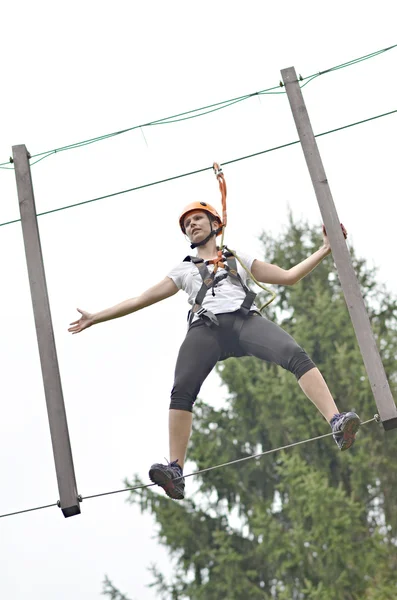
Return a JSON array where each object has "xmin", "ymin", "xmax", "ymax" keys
[{"xmin": 0, "ymin": 0, "xmax": 397, "ymax": 600}]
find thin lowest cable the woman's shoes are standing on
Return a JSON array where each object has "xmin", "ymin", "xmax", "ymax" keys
[{"xmin": 0, "ymin": 414, "xmax": 380, "ymax": 519}]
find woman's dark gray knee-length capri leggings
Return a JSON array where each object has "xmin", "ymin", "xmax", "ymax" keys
[{"xmin": 170, "ymin": 311, "xmax": 315, "ymax": 412}]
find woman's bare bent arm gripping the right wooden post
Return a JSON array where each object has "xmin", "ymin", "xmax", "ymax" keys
[{"xmin": 251, "ymin": 225, "xmax": 347, "ymax": 285}]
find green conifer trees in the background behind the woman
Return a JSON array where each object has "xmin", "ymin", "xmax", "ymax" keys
[{"xmin": 123, "ymin": 218, "xmax": 397, "ymax": 600}]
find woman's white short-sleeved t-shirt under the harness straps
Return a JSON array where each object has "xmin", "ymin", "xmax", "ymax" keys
[{"xmin": 167, "ymin": 252, "xmax": 255, "ymax": 318}]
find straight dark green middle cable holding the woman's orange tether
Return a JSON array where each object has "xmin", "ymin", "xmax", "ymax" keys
[{"xmin": 0, "ymin": 109, "xmax": 397, "ymax": 227}]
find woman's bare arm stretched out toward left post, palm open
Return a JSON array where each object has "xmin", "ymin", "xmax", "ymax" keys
[{"xmin": 68, "ymin": 277, "xmax": 179, "ymax": 334}]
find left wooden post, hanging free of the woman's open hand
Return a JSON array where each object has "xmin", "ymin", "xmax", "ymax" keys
[{"xmin": 12, "ymin": 145, "xmax": 80, "ymax": 517}]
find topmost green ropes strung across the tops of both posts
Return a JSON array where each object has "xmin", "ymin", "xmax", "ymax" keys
[{"xmin": 0, "ymin": 44, "xmax": 397, "ymax": 170}]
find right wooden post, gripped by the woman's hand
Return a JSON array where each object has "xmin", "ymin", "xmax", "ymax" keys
[{"xmin": 281, "ymin": 67, "xmax": 397, "ymax": 430}]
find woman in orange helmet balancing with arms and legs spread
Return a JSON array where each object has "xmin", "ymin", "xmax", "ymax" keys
[{"xmin": 69, "ymin": 202, "xmax": 360, "ymax": 500}]
